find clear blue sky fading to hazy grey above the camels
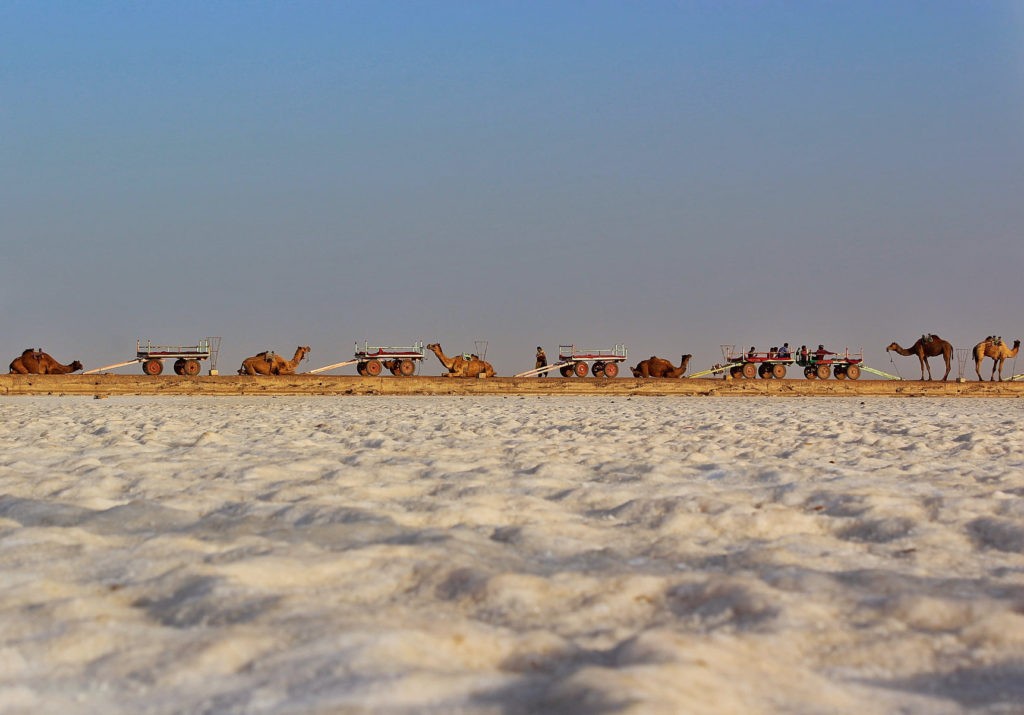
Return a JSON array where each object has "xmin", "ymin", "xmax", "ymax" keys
[{"xmin": 0, "ymin": 0, "xmax": 1024, "ymax": 377}]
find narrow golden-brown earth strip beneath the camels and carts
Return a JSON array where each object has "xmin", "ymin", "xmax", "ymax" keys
[{"xmin": 0, "ymin": 375, "xmax": 1024, "ymax": 397}]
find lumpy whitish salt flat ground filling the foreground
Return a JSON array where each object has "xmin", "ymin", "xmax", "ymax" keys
[{"xmin": 0, "ymin": 396, "xmax": 1024, "ymax": 715}]
